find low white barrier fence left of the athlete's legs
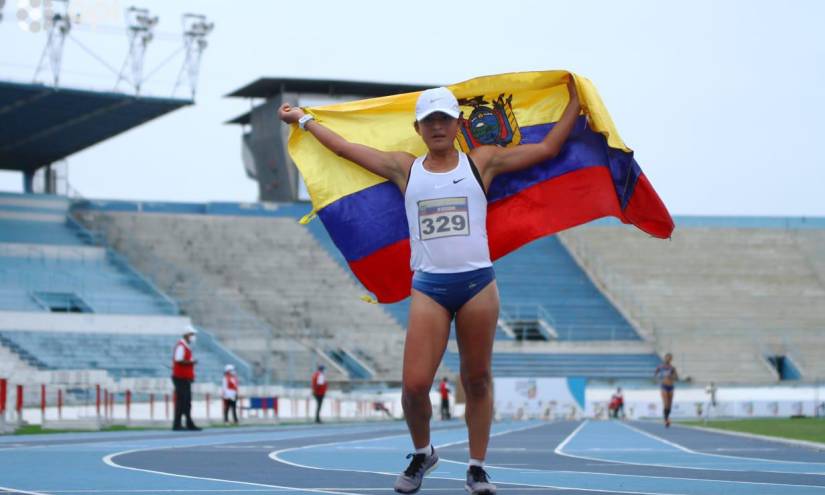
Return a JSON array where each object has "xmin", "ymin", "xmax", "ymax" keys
[{"xmin": 0, "ymin": 378, "xmax": 412, "ymax": 432}]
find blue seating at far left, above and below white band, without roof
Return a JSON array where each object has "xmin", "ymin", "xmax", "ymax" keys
[{"xmin": 0, "ymin": 193, "xmax": 249, "ymax": 379}]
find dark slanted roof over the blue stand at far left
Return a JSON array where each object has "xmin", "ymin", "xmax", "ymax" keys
[{"xmin": 0, "ymin": 81, "xmax": 193, "ymax": 172}]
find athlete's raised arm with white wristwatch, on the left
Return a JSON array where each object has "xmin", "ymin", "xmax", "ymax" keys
[{"xmin": 278, "ymin": 103, "xmax": 415, "ymax": 192}]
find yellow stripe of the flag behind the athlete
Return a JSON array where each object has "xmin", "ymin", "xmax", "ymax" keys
[{"xmin": 288, "ymin": 71, "xmax": 630, "ymax": 211}]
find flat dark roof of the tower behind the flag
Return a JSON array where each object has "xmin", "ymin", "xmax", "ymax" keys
[{"xmin": 225, "ymin": 77, "xmax": 434, "ymax": 124}]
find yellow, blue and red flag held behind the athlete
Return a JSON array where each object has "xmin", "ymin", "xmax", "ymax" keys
[{"xmin": 289, "ymin": 71, "xmax": 673, "ymax": 303}]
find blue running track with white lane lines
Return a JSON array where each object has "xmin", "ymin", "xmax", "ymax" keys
[{"xmin": 0, "ymin": 421, "xmax": 825, "ymax": 495}]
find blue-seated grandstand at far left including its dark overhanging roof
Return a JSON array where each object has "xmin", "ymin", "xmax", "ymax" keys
[{"xmin": 0, "ymin": 78, "xmax": 247, "ymax": 392}]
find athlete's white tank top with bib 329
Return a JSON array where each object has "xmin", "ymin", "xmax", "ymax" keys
[{"xmin": 404, "ymin": 152, "xmax": 493, "ymax": 273}]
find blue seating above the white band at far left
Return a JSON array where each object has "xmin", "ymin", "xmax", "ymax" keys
[{"xmin": 0, "ymin": 193, "xmax": 179, "ymax": 314}]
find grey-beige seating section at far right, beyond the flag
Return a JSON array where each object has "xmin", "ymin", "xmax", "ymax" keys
[{"xmin": 562, "ymin": 227, "xmax": 825, "ymax": 383}]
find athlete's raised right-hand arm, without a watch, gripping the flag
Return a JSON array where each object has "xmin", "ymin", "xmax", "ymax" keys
[{"xmin": 470, "ymin": 75, "xmax": 581, "ymax": 187}]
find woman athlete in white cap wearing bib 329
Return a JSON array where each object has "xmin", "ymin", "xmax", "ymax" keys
[{"xmin": 278, "ymin": 76, "xmax": 580, "ymax": 494}]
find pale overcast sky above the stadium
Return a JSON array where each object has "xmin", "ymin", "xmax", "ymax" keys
[{"xmin": 0, "ymin": 0, "xmax": 825, "ymax": 216}]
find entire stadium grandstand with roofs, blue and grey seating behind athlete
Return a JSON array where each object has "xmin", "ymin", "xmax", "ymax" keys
[{"xmin": 0, "ymin": 21, "xmax": 825, "ymax": 430}]
